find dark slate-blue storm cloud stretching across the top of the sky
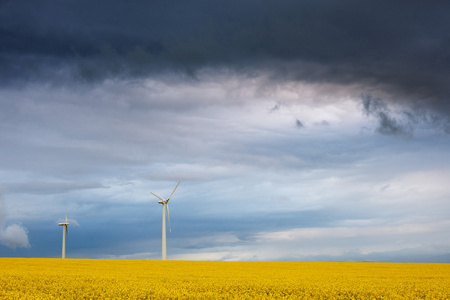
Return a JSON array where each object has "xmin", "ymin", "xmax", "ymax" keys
[{"xmin": 0, "ymin": 0, "xmax": 450, "ymax": 114}]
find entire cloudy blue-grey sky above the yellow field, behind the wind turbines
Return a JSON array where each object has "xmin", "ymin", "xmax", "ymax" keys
[{"xmin": 0, "ymin": 0, "xmax": 450, "ymax": 263}]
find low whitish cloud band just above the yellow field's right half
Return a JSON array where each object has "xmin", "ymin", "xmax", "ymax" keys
[{"xmin": 246, "ymin": 221, "xmax": 450, "ymax": 260}]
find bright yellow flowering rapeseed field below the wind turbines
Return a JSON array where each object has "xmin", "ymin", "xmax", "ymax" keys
[{"xmin": 0, "ymin": 258, "xmax": 450, "ymax": 299}]
